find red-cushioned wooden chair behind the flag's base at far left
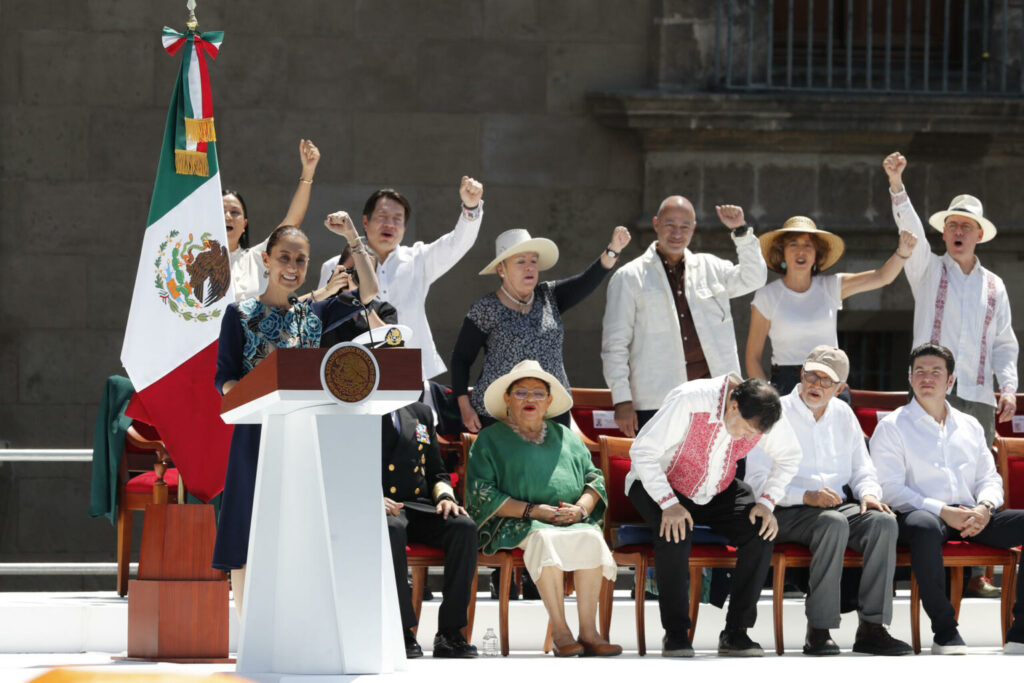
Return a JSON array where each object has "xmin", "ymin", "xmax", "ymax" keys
[{"xmin": 117, "ymin": 420, "xmax": 184, "ymax": 597}]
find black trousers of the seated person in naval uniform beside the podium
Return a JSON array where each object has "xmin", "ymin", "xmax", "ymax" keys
[{"xmin": 387, "ymin": 508, "xmax": 477, "ymax": 633}]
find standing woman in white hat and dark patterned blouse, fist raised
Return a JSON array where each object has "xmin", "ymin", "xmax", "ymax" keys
[{"xmin": 452, "ymin": 225, "xmax": 630, "ymax": 432}]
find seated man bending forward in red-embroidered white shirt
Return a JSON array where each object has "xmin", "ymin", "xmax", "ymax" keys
[{"xmin": 626, "ymin": 375, "xmax": 800, "ymax": 657}]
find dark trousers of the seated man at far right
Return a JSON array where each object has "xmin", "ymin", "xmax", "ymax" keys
[{"xmin": 897, "ymin": 510, "xmax": 1024, "ymax": 642}]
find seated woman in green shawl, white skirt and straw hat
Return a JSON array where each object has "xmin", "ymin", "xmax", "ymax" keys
[{"xmin": 466, "ymin": 360, "xmax": 623, "ymax": 656}]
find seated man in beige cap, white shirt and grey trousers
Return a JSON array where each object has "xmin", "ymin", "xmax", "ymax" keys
[{"xmin": 744, "ymin": 345, "xmax": 913, "ymax": 655}]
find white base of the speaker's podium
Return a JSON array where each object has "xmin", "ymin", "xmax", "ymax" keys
[{"xmin": 237, "ymin": 405, "xmax": 406, "ymax": 682}]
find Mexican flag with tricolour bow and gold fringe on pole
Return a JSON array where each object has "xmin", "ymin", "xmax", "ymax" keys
[{"xmin": 121, "ymin": 27, "xmax": 234, "ymax": 501}]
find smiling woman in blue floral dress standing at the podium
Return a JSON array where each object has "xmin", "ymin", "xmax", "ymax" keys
[{"xmin": 213, "ymin": 212, "xmax": 377, "ymax": 615}]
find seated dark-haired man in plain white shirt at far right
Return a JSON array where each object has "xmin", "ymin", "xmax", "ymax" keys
[{"xmin": 870, "ymin": 343, "xmax": 1024, "ymax": 654}]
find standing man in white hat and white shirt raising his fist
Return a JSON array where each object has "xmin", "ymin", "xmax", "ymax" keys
[{"xmin": 882, "ymin": 152, "xmax": 1019, "ymax": 444}]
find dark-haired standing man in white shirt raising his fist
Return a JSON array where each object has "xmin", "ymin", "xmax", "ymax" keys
[{"xmin": 321, "ymin": 176, "xmax": 483, "ymax": 385}]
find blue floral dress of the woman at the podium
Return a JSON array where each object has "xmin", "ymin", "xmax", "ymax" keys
[{"xmin": 213, "ymin": 297, "xmax": 358, "ymax": 570}]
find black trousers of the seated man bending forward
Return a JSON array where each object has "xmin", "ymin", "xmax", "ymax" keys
[{"xmin": 629, "ymin": 479, "xmax": 775, "ymax": 635}]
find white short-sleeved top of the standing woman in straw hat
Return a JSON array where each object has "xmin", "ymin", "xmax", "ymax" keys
[{"xmin": 751, "ymin": 274, "xmax": 843, "ymax": 366}]
